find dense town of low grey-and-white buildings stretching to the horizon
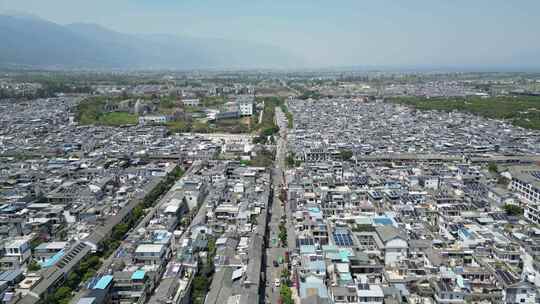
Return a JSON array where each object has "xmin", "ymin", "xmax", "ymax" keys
[{"xmin": 0, "ymin": 70, "xmax": 540, "ymax": 304}]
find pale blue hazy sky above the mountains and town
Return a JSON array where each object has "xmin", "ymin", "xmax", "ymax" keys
[{"xmin": 0, "ymin": 0, "xmax": 540, "ymax": 67}]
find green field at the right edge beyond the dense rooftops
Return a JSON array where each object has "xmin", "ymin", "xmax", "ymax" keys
[{"xmin": 387, "ymin": 96, "xmax": 540, "ymax": 130}]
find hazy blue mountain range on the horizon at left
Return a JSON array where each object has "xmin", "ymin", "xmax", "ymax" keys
[{"xmin": 0, "ymin": 15, "xmax": 301, "ymax": 69}]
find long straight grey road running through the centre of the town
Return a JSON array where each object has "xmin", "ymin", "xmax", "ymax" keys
[{"xmin": 265, "ymin": 108, "xmax": 295, "ymax": 303}]
